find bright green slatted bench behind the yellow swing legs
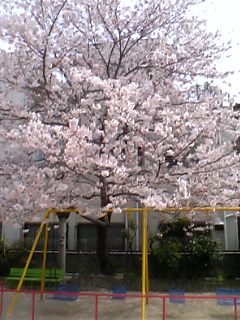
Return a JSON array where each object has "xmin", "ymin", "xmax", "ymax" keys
[{"xmin": 5, "ymin": 268, "xmax": 64, "ymax": 284}]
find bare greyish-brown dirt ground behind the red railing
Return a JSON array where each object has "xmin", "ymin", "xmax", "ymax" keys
[{"xmin": 0, "ymin": 292, "xmax": 240, "ymax": 320}]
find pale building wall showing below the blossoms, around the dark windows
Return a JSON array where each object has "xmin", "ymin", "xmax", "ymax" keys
[{"xmin": 2, "ymin": 212, "xmax": 240, "ymax": 251}]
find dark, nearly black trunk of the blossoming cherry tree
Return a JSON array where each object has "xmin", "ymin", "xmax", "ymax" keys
[{"xmin": 97, "ymin": 179, "xmax": 114, "ymax": 275}]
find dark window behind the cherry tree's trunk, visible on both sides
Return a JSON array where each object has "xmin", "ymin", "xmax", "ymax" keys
[{"xmin": 77, "ymin": 223, "xmax": 124, "ymax": 252}]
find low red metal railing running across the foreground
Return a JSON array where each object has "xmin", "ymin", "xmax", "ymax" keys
[{"xmin": 0, "ymin": 286, "xmax": 240, "ymax": 320}]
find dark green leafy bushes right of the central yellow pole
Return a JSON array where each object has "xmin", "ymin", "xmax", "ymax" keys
[{"xmin": 150, "ymin": 218, "xmax": 223, "ymax": 278}]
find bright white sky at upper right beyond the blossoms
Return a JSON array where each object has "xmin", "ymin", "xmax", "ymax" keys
[{"xmin": 0, "ymin": 0, "xmax": 240, "ymax": 102}]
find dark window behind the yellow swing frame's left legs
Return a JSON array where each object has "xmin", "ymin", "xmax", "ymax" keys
[{"xmin": 23, "ymin": 223, "xmax": 68, "ymax": 251}]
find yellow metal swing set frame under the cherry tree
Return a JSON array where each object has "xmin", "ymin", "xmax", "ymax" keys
[{"xmin": 9, "ymin": 207, "xmax": 240, "ymax": 320}]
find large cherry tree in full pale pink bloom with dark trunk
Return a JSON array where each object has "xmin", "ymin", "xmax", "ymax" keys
[{"xmin": 0, "ymin": 0, "xmax": 239, "ymax": 273}]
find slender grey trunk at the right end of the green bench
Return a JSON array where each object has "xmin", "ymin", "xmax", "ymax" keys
[{"xmin": 57, "ymin": 212, "xmax": 69, "ymax": 274}]
